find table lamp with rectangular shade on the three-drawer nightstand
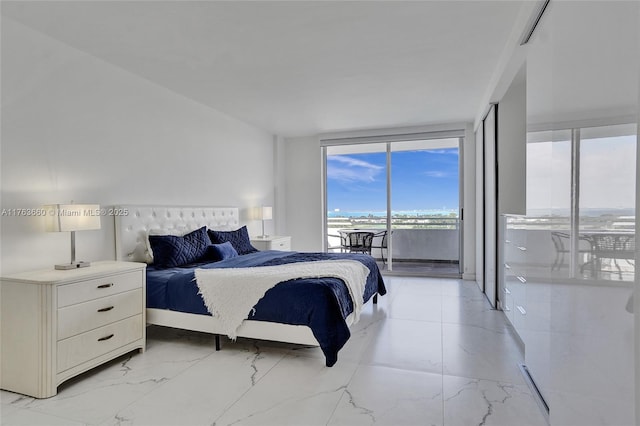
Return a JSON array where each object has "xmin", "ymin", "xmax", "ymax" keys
[{"xmin": 44, "ymin": 204, "xmax": 100, "ymax": 270}]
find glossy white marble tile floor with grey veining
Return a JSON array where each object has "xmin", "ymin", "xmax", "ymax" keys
[{"xmin": 0, "ymin": 277, "xmax": 546, "ymax": 426}]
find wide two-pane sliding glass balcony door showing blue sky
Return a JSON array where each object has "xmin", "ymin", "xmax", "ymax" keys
[{"xmin": 325, "ymin": 137, "xmax": 461, "ymax": 276}]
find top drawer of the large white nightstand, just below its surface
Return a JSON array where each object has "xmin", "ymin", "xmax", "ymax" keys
[{"xmin": 58, "ymin": 272, "xmax": 142, "ymax": 307}]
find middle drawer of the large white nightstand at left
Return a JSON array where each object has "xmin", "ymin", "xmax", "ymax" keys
[{"xmin": 58, "ymin": 288, "xmax": 142, "ymax": 340}]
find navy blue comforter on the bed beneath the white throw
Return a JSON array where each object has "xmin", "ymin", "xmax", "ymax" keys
[{"xmin": 147, "ymin": 251, "xmax": 387, "ymax": 367}]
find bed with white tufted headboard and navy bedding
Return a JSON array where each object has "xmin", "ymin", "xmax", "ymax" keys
[{"xmin": 114, "ymin": 205, "xmax": 386, "ymax": 366}]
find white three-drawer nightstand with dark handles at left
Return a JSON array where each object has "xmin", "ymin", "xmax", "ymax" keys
[{"xmin": 0, "ymin": 261, "xmax": 146, "ymax": 398}]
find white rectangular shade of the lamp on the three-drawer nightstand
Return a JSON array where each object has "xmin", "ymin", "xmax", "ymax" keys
[{"xmin": 43, "ymin": 204, "xmax": 100, "ymax": 232}]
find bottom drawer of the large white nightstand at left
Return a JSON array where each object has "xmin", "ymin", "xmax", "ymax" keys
[{"xmin": 57, "ymin": 314, "xmax": 143, "ymax": 373}]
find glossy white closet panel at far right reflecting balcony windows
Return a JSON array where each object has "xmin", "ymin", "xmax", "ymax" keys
[{"xmin": 524, "ymin": 1, "xmax": 640, "ymax": 426}]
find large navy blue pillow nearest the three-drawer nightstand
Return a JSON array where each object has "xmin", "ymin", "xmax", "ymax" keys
[{"xmin": 149, "ymin": 226, "xmax": 211, "ymax": 268}]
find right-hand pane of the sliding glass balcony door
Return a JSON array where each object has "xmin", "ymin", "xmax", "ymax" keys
[{"xmin": 390, "ymin": 138, "xmax": 460, "ymax": 275}]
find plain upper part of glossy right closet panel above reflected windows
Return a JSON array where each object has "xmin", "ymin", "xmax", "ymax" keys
[{"xmin": 526, "ymin": 1, "xmax": 640, "ymax": 127}]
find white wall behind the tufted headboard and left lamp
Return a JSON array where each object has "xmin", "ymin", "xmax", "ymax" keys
[{"xmin": 0, "ymin": 17, "xmax": 276, "ymax": 274}]
